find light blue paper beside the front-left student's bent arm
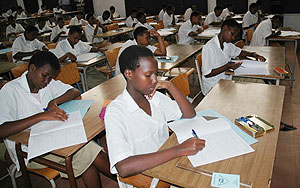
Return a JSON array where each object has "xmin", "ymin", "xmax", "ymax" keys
[{"xmin": 59, "ymin": 100, "xmax": 94, "ymax": 119}]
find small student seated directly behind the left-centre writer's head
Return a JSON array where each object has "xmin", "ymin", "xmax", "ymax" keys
[{"xmin": 50, "ymin": 17, "xmax": 69, "ymax": 42}]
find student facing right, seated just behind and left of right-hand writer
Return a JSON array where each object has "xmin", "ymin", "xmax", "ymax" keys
[{"xmin": 178, "ymin": 11, "xmax": 203, "ymax": 44}]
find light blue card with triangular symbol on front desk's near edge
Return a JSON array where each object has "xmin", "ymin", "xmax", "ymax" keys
[{"xmin": 211, "ymin": 172, "xmax": 240, "ymax": 188}]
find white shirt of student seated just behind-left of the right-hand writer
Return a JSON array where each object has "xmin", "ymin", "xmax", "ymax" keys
[{"xmin": 178, "ymin": 20, "xmax": 201, "ymax": 44}]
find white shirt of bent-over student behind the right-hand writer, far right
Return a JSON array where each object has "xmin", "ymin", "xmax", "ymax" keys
[{"xmin": 250, "ymin": 19, "xmax": 272, "ymax": 46}]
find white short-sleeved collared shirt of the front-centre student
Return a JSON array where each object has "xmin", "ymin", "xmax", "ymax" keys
[{"xmin": 104, "ymin": 89, "xmax": 182, "ymax": 188}]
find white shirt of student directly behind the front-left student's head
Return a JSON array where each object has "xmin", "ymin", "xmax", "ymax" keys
[{"xmin": 12, "ymin": 33, "xmax": 46, "ymax": 63}]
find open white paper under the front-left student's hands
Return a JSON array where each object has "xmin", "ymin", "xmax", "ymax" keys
[{"xmin": 27, "ymin": 111, "xmax": 87, "ymax": 160}]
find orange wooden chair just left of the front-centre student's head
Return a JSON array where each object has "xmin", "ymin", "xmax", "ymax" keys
[{"xmin": 96, "ymin": 47, "xmax": 121, "ymax": 79}]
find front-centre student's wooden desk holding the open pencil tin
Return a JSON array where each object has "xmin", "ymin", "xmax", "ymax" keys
[{"xmin": 143, "ymin": 80, "xmax": 285, "ymax": 188}]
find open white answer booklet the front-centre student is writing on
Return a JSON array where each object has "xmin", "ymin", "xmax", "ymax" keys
[{"xmin": 169, "ymin": 116, "xmax": 254, "ymax": 167}]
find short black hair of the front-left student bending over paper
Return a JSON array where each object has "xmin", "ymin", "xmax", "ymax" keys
[{"xmin": 28, "ymin": 51, "xmax": 60, "ymax": 71}]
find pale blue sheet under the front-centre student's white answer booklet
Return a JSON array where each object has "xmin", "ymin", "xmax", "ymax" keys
[{"xmin": 197, "ymin": 109, "xmax": 258, "ymax": 145}]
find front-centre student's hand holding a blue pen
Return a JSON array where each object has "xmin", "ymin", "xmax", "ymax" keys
[{"xmin": 178, "ymin": 137, "xmax": 205, "ymax": 156}]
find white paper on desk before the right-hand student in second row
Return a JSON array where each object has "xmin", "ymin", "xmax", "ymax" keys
[{"xmin": 233, "ymin": 60, "xmax": 270, "ymax": 76}]
